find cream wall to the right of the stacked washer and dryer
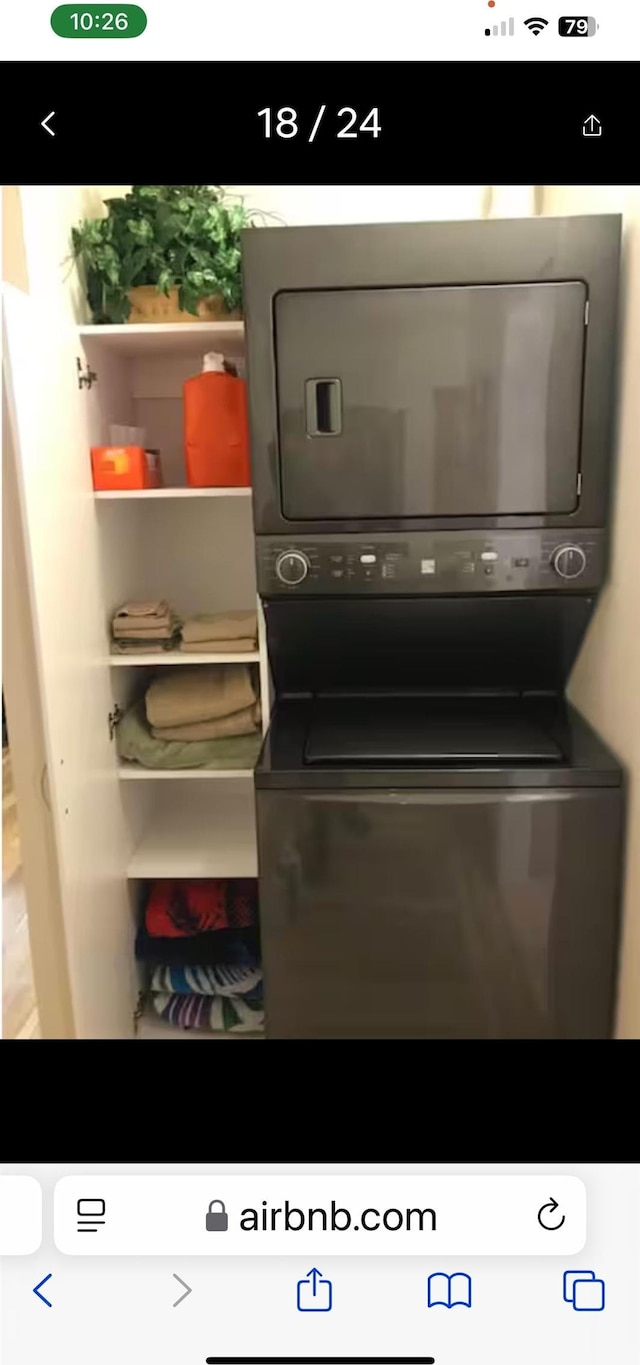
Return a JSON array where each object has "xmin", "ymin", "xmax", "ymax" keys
[{"xmin": 543, "ymin": 186, "xmax": 640, "ymax": 1039}]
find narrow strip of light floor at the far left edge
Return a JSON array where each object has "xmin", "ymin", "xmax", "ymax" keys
[{"xmin": 3, "ymin": 748, "xmax": 40, "ymax": 1039}]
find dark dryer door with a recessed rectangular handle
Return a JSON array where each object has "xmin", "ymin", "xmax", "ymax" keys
[{"xmin": 274, "ymin": 281, "xmax": 587, "ymax": 521}]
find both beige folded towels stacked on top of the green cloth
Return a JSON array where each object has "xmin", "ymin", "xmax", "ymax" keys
[{"xmin": 145, "ymin": 663, "xmax": 261, "ymax": 741}]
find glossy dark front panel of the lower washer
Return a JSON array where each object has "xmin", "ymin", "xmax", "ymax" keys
[{"xmin": 257, "ymin": 788, "xmax": 622, "ymax": 1039}]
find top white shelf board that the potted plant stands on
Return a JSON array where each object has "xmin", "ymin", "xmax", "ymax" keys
[{"xmin": 78, "ymin": 321, "xmax": 244, "ymax": 358}]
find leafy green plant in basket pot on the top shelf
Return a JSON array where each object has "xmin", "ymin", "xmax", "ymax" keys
[{"xmin": 72, "ymin": 184, "xmax": 255, "ymax": 324}]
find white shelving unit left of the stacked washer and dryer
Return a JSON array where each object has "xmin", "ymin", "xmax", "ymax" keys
[{"xmin": 5, "ymin": 291, "xmax": 270, "ymax": 1040}]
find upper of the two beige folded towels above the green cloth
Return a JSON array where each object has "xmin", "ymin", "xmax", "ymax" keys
[{"xmin": 145, "ymin": 663, "xmax": 257, "ymax": 730}]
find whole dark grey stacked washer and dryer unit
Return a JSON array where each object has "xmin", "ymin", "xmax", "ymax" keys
[{"xmin": 244, "ymin": 216, "xmax": 624, "ymax": 1039}]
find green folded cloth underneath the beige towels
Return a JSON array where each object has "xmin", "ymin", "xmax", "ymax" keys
[{"xmin": 116, "ymin": 699, "xmax": 262, "ymax": 768}]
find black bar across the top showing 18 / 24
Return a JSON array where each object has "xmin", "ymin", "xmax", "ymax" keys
[{"xmin": 0, "ymin": 61, "xmax": 627, "ymax": 184}]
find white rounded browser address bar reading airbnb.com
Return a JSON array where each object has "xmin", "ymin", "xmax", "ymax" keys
[{"xmin": 55, "ymin": 1175, "xmax": 587, "ymax": 1256}]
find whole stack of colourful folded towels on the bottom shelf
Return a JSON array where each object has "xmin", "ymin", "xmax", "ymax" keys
[{"xmin": 136, "ymin": 879, "xmax": 263, "ymax": 1033}]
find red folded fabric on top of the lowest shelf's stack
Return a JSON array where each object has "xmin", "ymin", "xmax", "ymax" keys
[{"xmin": 145, "ymin": 878, "xmax": 258, "ymax": 938}]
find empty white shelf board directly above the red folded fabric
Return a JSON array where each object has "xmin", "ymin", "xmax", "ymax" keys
[{"xmin": 127, "ymin": 789, "xmax": 258, "ymax": 880}]
